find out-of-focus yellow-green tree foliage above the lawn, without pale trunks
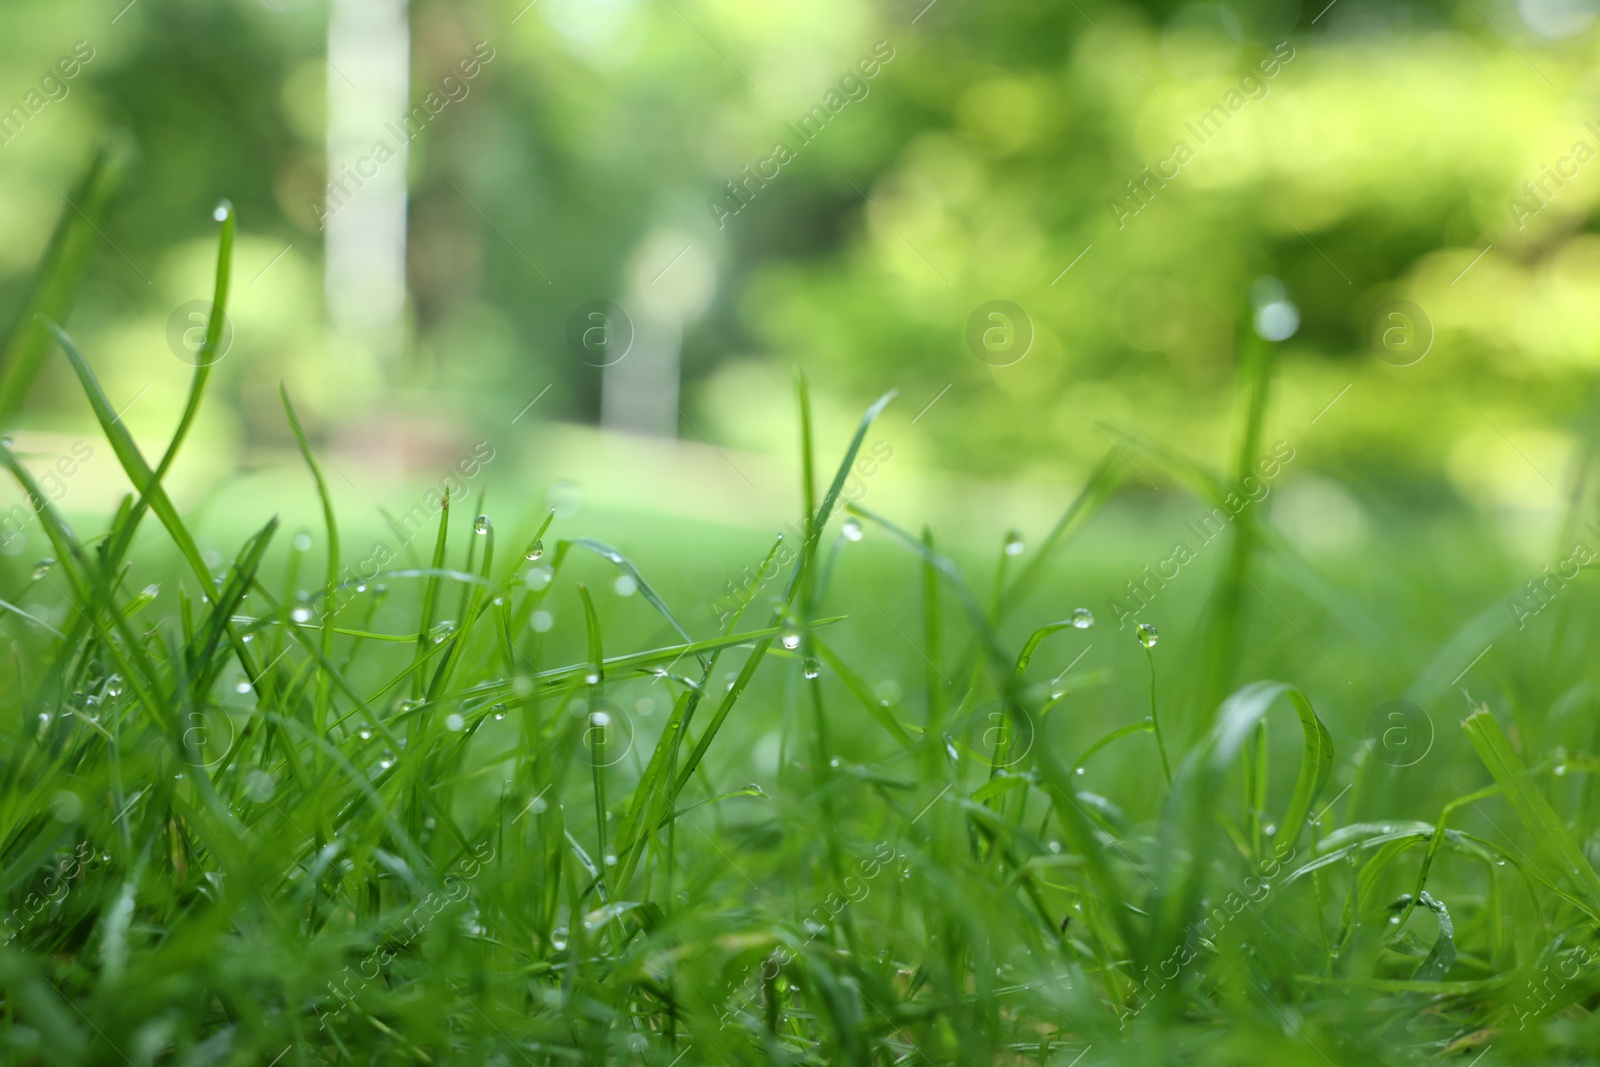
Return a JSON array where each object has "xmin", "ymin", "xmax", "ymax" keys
[{"xmin": 0, "ymin": 0, "xmax": 1600, "ymax": 521}]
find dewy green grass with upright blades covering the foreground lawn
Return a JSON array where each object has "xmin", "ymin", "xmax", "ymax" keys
[{"xmin": 0, "ymin": 211, "xmax": 1600, "ymax": 1067}]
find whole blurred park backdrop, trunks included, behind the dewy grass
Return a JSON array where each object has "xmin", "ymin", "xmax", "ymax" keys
[{"xmin": 0, "ymin": 0, "xmax": 1600, "ymax": 767}]
